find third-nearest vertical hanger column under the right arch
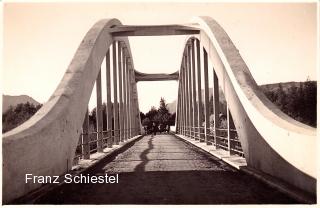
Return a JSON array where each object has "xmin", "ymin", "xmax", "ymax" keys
[{"xmin": 203, "ymin": 48, "xmax": 210, "ymax": 143}]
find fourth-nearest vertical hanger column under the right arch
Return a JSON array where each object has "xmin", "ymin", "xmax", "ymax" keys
[{"xmin": 196, "ymin": 39, "xmax": 203, "ymax": 140}]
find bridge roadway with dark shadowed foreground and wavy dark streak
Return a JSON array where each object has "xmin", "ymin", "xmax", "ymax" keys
[{"xmin": 36, "ymin": 135, "xmax": 297, "ymax": 204}]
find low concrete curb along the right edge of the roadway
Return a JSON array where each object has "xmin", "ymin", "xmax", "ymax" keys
[{"xmin": 174, "ymin": 134, "xmax": 317, "ymax": 204}]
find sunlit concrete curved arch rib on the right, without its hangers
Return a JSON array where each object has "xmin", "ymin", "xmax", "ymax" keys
[{"xmin": 180, "ymin": 17, "xmax": 316, "ymax": 195}]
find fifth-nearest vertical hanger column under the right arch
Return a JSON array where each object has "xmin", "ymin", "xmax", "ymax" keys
[{"xmin": 190, "ymin": 39, "xmax": 198, "ymax": 139}]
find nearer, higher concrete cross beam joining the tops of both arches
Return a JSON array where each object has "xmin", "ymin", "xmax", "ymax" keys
[{"xmin": 111, "ymin": 25, "xmax": 200, "ymax": 37}]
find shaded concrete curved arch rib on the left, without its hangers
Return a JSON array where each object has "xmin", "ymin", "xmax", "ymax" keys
[{"xmin": 2, "ymin": 19, "xmax": 138, "ymax": 202}]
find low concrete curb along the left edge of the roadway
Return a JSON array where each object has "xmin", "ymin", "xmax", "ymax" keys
[{"xmin": 7, "ymin": 135, "xmax": 144, "ymax": 205}]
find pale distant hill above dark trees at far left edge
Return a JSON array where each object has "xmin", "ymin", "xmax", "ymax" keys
[{"xmin": 2, "ymin": 95, "xmax": 40, "ymax": 114}]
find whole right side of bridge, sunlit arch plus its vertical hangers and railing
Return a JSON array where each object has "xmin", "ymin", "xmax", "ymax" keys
[{"xmin": 176, "ymin": 17, "xmax": 316, "ymax": 195}]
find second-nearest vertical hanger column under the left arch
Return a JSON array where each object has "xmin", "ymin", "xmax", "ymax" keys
[{"xmin": 96, "ymin": 69, "xmax": 103, "ymax": 152}]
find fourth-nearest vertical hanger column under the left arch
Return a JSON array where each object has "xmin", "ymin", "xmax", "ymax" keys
[{"xmin": 112, "ymin": 42, "xmax": 119, "ymax": 144}]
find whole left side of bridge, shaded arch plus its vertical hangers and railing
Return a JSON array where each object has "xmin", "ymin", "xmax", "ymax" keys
[{"xmin": 2, "ymin": 19, "xmax": 140, "ymax": 203}]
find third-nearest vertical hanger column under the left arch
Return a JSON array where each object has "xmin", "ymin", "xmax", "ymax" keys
[{"xmin": 106, "ymin": 50, "xmax": 113, "ymax": 148}]
